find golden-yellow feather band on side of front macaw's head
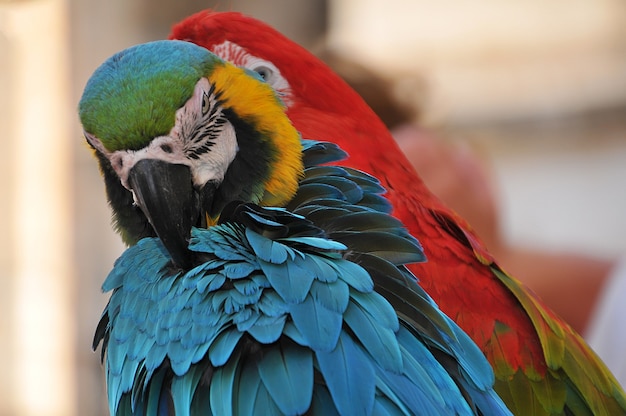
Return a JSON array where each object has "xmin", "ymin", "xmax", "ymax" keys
[{"xmin": 210, "ymin": 64, "xmax": 304, "ymax": 206}]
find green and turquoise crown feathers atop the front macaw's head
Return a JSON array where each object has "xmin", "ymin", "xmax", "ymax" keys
[{"xmin": 79, "ymin": 41, "xmax": 218, "ymax": 151}]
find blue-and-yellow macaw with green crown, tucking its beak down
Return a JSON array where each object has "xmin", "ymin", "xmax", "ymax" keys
[{"xmin": 79, "ymin": 40, "xmax": 510, "ymax": 415}]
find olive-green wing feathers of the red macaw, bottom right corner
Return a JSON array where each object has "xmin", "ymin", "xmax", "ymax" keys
[{"xmin": 492, "ymin": 267, "xmax": 626, "ymax": 415}]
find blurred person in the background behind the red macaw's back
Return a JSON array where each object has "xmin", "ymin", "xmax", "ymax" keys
[{"xmin": 319, "ymin": 51, "xmax": 626, "ymax": 385}]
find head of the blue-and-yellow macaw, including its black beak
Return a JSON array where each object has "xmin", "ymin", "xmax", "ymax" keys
[{"xmin": 79, "ymin": 40, "xmax": 303, "ymax": 268}]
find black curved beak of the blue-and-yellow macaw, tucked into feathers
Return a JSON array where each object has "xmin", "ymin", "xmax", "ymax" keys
[{"xmin": 128, "ymin": 159, "xmax": 200, "ymax": 270}]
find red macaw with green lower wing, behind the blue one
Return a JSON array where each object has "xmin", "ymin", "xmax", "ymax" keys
[{"xmin": 170, "ymin": 11, "xmax": 626, "ymax": 415}]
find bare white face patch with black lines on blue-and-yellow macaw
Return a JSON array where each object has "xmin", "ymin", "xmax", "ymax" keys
[{"xmin": 85, "ymin": 78, "xmax": 238, "ymax": 191}]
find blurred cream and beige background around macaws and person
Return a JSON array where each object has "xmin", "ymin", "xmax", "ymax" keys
[{"xmin": 0, "ymin": 0, "xmax": 626, "ymax": 415}]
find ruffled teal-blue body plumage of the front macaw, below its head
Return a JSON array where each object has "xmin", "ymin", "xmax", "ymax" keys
[{"xmin": 94, "ymin": 141, "xmax": 508, "ymax": 415}]
